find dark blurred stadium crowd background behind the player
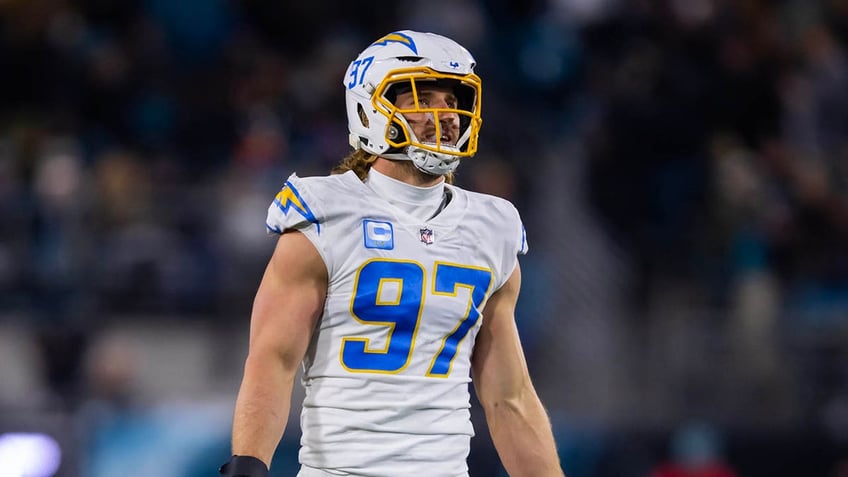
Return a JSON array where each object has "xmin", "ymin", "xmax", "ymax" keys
[{"xmin": 0, "ymin": 0, "xmax": 848, "ymax": 477}]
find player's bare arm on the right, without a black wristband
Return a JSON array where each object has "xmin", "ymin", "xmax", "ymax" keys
[{"xmin": 472, "ymin": 265, "xmax": 564, "ymax": 477}]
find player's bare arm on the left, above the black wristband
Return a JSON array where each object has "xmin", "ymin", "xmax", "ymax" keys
[{"xmin": 225, "ymin": 232, "xmax": 327, "ymax": 475}]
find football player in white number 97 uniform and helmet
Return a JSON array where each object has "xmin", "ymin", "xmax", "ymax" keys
[{"xmin": 221, "ymin": 31, "xmax": 563, "ymax": 477}]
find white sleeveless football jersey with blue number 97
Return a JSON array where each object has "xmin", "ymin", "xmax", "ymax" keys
[{"xmin": 266, "ymin": 172, "xmax": 527, "ymax": 477}]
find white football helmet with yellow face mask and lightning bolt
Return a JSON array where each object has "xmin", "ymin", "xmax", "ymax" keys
[{"xmin": 343, "ymin": 30, "xmax": 482, "ymax": 175}]
